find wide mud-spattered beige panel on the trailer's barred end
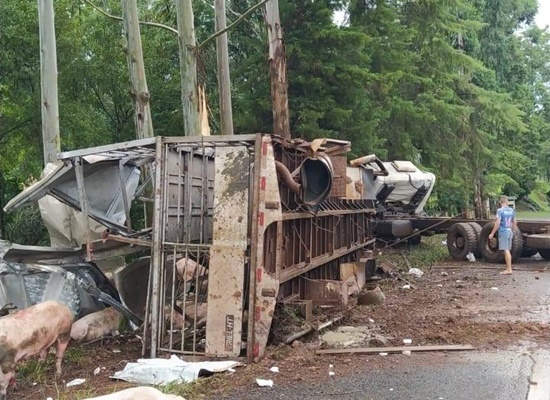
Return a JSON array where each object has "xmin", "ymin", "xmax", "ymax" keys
[{"xmin": 206, "ymin": 146, "xmax": 250, "ymax": 356}]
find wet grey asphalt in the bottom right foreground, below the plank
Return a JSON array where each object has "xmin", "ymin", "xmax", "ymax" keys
[{"xmin": 222, "ymin": 347, "xmax": 550, "ymax": 400}]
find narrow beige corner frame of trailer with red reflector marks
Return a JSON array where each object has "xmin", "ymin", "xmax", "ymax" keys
[{"xmin": 251, "ymin": 135, "xmax": 283, "ymax": 361}]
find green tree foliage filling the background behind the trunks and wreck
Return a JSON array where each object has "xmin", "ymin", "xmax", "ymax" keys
[{"xmin": 0, "ymin": 0, "xmax": 550, "ymax": 244}]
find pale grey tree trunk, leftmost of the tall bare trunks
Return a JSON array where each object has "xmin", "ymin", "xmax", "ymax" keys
[{"xmin": 38, "ymin": 0, "xmax": 61, "ymax": 165}]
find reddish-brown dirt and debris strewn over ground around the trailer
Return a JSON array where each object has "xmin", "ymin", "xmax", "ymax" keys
[{"xmin": 13, "ymin": 261, "xmax": 550, "ymax": 400}]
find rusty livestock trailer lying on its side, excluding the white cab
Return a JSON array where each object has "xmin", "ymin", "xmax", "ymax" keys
[{"xmin": 5, "ymin": 134, "xmax": 377, "ymax": 360}]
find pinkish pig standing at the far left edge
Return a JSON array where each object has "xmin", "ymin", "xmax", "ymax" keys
[{"xmin": 0, "ymin": 301, "xmax": 74, "ymax": 400}]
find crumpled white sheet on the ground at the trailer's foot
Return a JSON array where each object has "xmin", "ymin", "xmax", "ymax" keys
[{"xmin": 111, "ymin": 355, "xmax": 242, "ymax": 385}]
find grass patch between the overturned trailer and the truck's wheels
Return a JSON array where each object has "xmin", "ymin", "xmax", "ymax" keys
[{"xmin": 376, "ymin": 234, "xmax": 449, "ymax": 271}]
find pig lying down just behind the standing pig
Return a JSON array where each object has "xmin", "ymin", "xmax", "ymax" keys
[{"xmin": 71, "ymin": 307, "xmax": 123, "ymax": 342}]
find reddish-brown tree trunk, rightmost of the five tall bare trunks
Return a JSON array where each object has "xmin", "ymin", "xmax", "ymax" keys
[{"xmin": 264, "ymin": 0, "xmax": 291, "ymax": 139}]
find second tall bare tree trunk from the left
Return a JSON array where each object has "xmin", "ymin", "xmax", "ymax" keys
[{"xmin": 121, "ymin": 0, "xmax": 153, "ymax": 139}]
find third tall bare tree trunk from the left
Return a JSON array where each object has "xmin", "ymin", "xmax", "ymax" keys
[{"xmin": 176, "ymin": 0, "xmax": 201, "ymax": 136}]
